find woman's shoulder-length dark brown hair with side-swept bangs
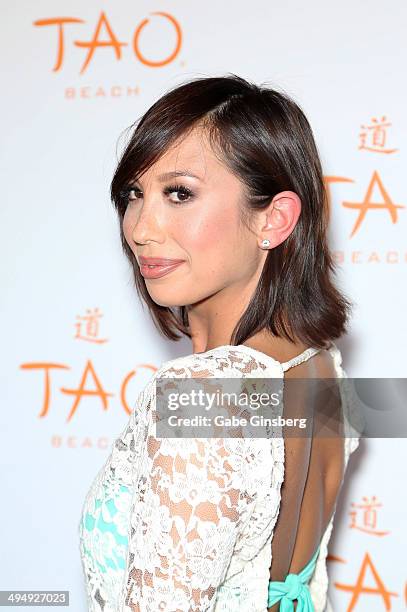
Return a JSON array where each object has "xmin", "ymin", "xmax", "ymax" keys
[{"xmin": 110, "ymin": 73, "xmax": 353, "ymax": 348}]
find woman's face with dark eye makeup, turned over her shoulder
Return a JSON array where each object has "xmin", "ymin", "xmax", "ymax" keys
[{"xmin": 123, "ymin": 130, "xmax": 267, "ymax": 306}]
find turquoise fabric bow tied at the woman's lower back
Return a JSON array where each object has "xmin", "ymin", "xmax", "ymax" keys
[{"xmin": 267, "ymin": 546, "xmax": 320, "ymax": 612}]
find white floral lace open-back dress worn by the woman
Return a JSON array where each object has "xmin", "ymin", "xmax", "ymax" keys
[{"xmin": 79, "ymin": 343, "xmax": 359, "ymax": 612}]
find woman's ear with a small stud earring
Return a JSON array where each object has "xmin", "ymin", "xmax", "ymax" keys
[{"xmin": 256, "ymin": 191, "xmax": 301, "ymax": 249}]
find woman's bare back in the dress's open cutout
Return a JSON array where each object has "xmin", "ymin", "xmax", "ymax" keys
[{"xmin": 244, "ymin": 346, "xmax": 344, "ymax": 612}]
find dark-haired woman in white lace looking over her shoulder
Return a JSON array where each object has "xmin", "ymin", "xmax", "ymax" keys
[{"xmin": 80, "ymin": 75, "xmax": 364, "ymax": 612}]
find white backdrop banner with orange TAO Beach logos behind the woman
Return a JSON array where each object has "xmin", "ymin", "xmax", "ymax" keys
[{"xmin": 0, "ymin": 0, "xmax": 407, "ymax": 612}]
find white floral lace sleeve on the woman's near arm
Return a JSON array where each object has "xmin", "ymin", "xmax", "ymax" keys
[{"xmin": 125, "ymin": 356, "xmax": 252, "ymax": 612}]
